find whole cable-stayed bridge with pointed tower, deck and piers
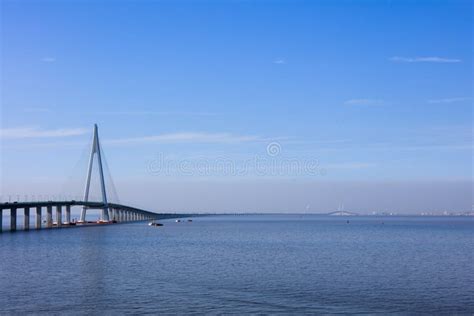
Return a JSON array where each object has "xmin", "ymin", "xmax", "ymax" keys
[{"xmin": 0, "ymin": 124, "xmax": 188, "ymax": 232}]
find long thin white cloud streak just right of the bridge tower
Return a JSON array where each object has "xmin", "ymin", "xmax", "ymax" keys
[{"xmin": 106, "ymin": 132, "xmax": 263, "ymax": 144}]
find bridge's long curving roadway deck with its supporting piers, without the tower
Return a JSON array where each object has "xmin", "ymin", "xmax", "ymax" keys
[{"xmin": 0, "ymin": 200, "xmax": 190, "ymax": 232}]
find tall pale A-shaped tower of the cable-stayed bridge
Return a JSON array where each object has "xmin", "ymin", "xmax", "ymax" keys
[{"xmin": 80, "ymin": 124, "xmax": 109, "ymax": 222}]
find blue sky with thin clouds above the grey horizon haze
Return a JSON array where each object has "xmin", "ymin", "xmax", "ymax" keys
[{"xmin": 0, "ymin": 1, "xmax": 473, "ymax": 212}]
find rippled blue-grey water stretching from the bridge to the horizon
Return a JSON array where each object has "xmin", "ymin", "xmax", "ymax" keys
[{"xmin": 0, "ymin": 215, "xmax": 474, "ymax": 314}]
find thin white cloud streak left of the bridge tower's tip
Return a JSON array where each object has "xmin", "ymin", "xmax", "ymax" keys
[{"xmin": 0, "ymin": 127, "xmax": 90, "ymax": 139}]
